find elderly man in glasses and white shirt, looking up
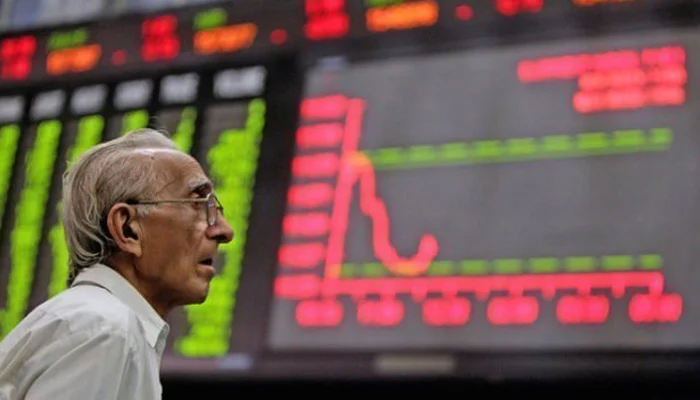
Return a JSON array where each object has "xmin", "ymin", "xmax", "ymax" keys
[{"xmin": 0, "ymin": 129, "xmax": 233, "ymax": 400}]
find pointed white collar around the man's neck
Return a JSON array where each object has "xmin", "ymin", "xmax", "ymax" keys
[{"xmin": 73, "ymin": 264, "xmax": 170, "ymax": 355}]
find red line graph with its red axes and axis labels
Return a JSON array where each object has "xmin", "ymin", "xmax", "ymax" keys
[{"xmin": 275, "ymin": 95, "xmax": 683, "ymax": 327}]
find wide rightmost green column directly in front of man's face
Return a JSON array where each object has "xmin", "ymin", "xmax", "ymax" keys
[{"xmin": 175, "ymin": 99, "xmax": 266, "ymax": 357}]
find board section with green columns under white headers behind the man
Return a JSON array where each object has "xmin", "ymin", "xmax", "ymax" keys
[{"xmin": 0, "ymin": 65, "xmax": 276, "ymax": 370}]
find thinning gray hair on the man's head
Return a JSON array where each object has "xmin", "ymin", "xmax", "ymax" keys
[{"xmin": 61, "ymin": 128, "xmax": 178, "ymax": 286}]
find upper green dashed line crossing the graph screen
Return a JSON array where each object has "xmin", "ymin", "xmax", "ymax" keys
[{"xmin": 364, "ymin": 128, "xmax": 673, "ymax": 170}]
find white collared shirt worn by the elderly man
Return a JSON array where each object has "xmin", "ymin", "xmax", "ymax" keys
[{"xmin": 0, "ymin": 264, "xmax": 170, "ymax": 400}]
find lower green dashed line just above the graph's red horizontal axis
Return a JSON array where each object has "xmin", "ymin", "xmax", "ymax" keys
[{"xmin": 340, "ymin": 254, "xmax": 663, "ymax": 279}]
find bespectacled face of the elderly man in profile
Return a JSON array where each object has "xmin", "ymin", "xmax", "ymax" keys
[{"xmin": 136, "ymin": 152, "xmax": 233, "ymax": 307}]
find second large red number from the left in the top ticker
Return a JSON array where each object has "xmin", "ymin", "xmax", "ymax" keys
[{"xmin": 141, "ymin": 15, "xmax": 180, "ymax": 62}]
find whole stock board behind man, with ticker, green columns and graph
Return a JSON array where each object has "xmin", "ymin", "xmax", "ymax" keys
[{"xmin": 0, "ymin": 0, "xmax": 700, "ymax": 376}]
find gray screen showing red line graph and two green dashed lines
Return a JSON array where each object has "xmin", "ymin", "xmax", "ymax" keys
[{"xmin": 268, "ymin": 26, "xmax": 700, "ymax": 352}]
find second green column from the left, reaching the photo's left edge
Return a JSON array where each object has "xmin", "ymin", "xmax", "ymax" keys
[{"xmin": 0, "ymin": 120, "xmax": 61, "ymax": 337}]
